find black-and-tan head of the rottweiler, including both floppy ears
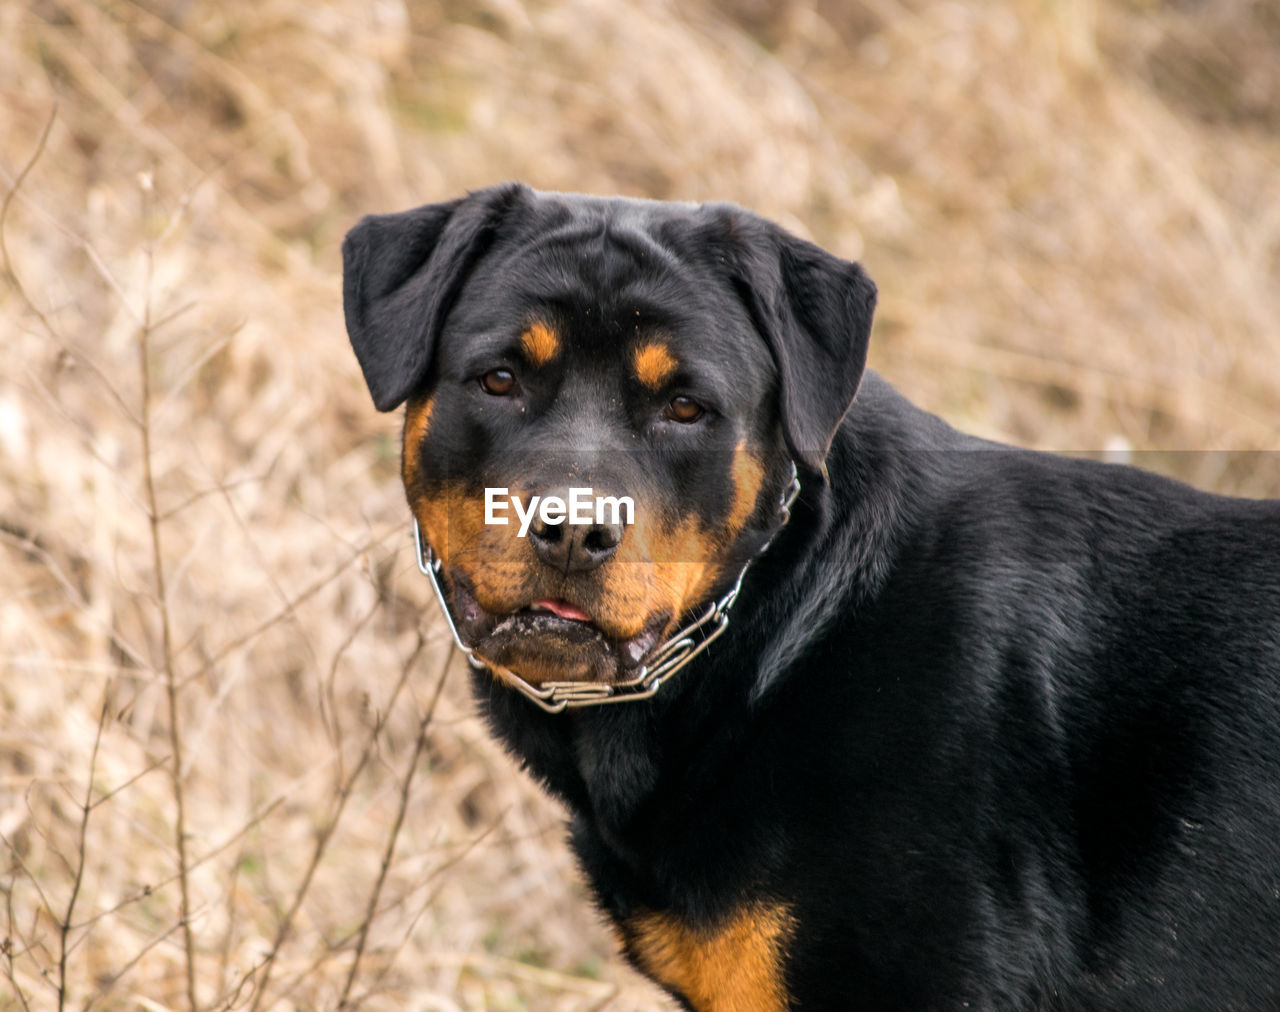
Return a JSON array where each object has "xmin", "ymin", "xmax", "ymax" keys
[{"xmin": 343, "ymin": 184, "xmax": 876, "ymax": 684}]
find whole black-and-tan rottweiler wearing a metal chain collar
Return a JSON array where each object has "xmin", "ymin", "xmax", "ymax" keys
[{"xmin": 343, "ymin": 184, "xmax": 1280, "ymax": 1012}]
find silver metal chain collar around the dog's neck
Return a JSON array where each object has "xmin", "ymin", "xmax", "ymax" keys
[{"xmin": 413, "ymin": 461, "xmax": 800, "ymax": 714}]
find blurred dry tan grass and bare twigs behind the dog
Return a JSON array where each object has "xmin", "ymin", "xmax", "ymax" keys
[{"xmin": 0, "ymin": 0, "xmax": 1280, "ymax": 1012}]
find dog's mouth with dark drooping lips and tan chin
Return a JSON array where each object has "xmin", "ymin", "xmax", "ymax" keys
[{"xmin": 449, "ymin": 573, "xmax": 671, "ymax": 686}]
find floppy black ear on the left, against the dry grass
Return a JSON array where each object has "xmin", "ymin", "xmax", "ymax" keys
[{"xmin": 342, "ymin": 183, "xmax": 529, "ymax": 411}]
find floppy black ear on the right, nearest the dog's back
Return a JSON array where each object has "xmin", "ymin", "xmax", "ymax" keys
[{"xmin": 717, "ymin": 206, "xmax": 876, "ymax": 476}]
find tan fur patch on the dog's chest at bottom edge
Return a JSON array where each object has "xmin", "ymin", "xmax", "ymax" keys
[{"xmin": 625, "ymin": 903, "xmax": 795, "ymax": 1012}]
